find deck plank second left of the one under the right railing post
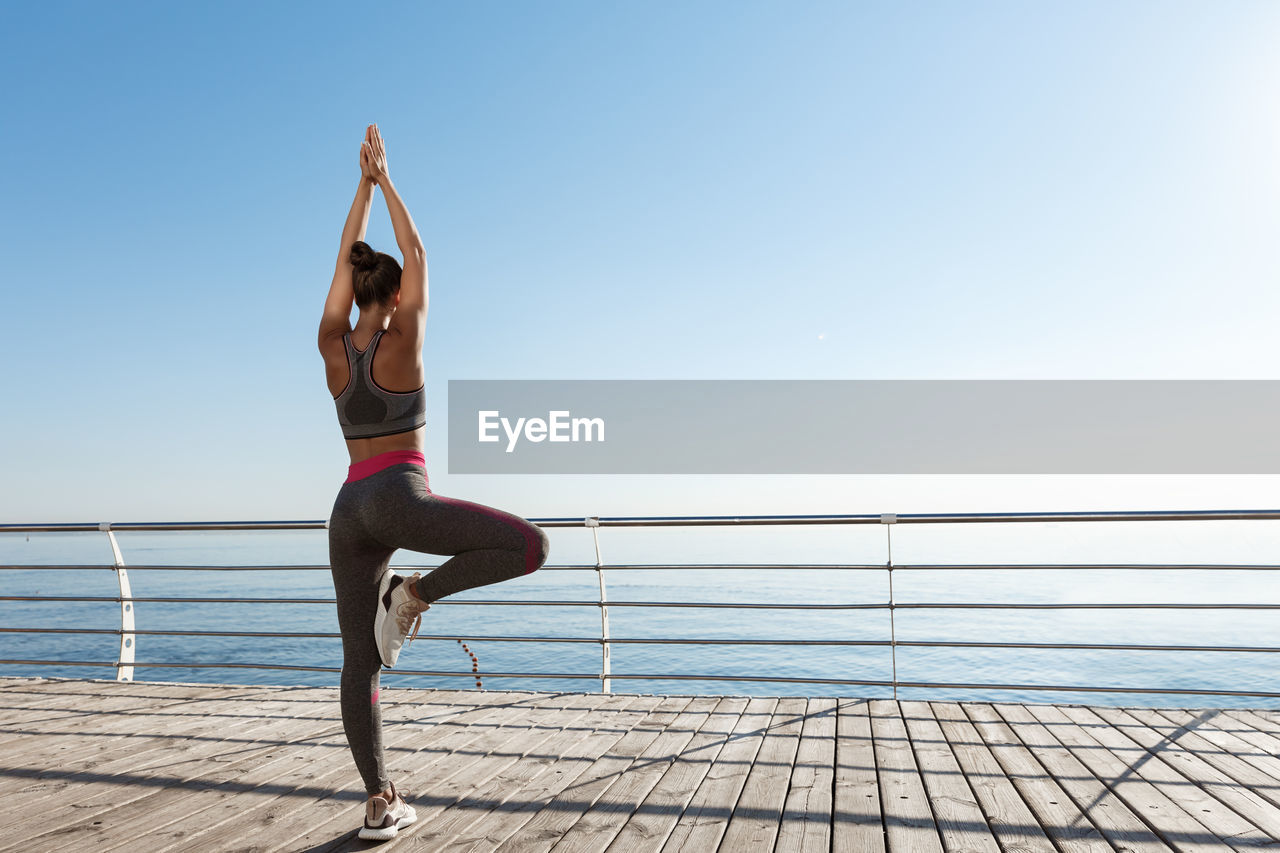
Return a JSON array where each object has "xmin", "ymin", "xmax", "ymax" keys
[{"xmin": 773, "ymin": 697, "xmax": 837, "ymax": 853}]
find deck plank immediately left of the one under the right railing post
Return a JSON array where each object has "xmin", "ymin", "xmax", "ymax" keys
[{"xmin": 831, "ymin": 697, "xmax": 884, "ymax": 853}]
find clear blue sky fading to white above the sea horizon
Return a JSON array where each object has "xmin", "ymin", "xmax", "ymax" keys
[{"xmin": 0, "ymin": 1, "xmax": 1280, "ymax": 521}]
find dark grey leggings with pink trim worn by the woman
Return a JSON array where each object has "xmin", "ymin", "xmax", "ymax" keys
[{"xmin": 329, "ymin": 464, "xmax": 548, "ymax": 794}]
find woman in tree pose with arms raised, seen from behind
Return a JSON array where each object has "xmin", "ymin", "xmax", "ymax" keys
[{"xmin": 319, "ymin": 124, "xmax": 548, "ymax": 840}]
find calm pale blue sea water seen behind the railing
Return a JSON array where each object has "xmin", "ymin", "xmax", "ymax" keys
[{"xmin": 0, "ymin": 514, "xmax": 1280, "ymax": 708}]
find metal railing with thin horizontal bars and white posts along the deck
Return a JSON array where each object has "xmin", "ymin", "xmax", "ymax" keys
[{"xmin": 0, "ymin": 510, "xmax": 1280, "ymax": 698}]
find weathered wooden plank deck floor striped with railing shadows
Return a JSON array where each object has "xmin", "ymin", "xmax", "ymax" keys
[{"xmin": 0, "ymin": 678, "xmax": 1280, "ymax": 853}]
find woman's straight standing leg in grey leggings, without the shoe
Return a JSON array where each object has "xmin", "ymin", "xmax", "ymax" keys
[{"xmin": 329, "ymin": 482, "xmax": 394, "ymax": 794}]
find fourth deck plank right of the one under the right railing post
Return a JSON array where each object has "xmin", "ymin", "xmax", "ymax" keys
[{"xmin": 991, "ymin": 703, "xmax": 1180, "ymax": 853}]
